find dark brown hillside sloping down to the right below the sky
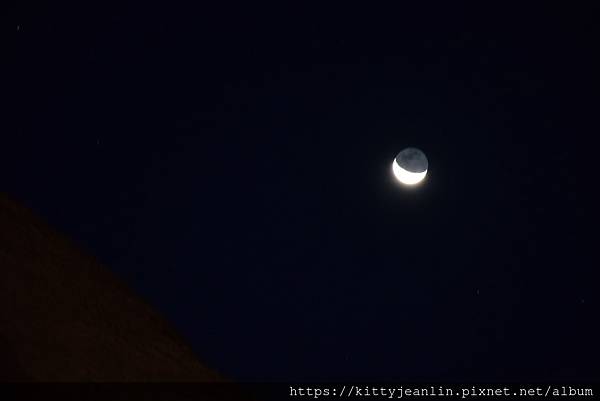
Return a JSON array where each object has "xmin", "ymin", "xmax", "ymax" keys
[{"xmin": 0, "ymin": 195, "xmax": 218, "ymax": 381}]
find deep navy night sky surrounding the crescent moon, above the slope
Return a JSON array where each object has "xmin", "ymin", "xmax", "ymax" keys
[{"xmin": 9, "ymin": 2, "xmax": 600, "ymax": 380}]
